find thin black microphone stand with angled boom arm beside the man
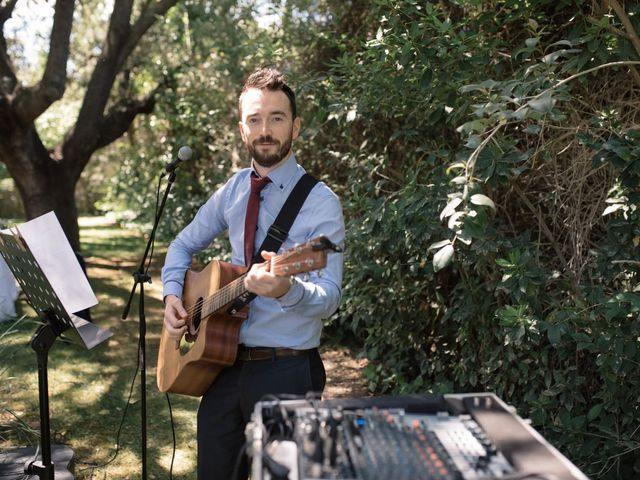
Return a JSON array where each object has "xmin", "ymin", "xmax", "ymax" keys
[{"xmin": 122, "ymin": 166, "xmax": 176, "ymax": 480}]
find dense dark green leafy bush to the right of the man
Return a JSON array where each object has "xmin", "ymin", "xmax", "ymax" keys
[{"xmin": 324, "ymin": 1, "xmax": 640, "ymax": 478}]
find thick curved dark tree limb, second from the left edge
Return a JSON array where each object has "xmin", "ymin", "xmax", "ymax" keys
[{"xmin": 14, "ymin": 0, "xmax": 75, "ymax": 125}]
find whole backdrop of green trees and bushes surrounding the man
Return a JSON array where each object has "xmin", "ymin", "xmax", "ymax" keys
[{"xmin": 0, "ymin": 0, "xmax": 640, "ymax": 478}]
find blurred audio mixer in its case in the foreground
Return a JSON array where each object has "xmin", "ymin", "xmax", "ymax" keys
[{"xmin": 247, "ymin": 393, "xmax": 587, "ymax": 480}]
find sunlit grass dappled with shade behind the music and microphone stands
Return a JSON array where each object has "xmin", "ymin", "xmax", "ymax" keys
[{"xmin": 0, "ymin": 218, "xmax": 198, "ymax": 480}]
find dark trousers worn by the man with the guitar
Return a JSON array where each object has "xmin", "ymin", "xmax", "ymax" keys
[{"xmin": 198, "ymin": 350, "xmax": 326, "ymax": 480}]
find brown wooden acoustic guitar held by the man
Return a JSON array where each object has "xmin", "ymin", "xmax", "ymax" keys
[{"xmin": 157, "ymin": 236, "xmax": 339, "ymax": 397}]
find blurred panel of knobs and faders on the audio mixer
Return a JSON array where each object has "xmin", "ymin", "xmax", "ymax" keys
[{"xmin": 294, "ymin": 408, "xmax": 513, "ymax": 480}]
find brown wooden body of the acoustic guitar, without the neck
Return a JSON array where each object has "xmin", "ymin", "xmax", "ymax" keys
[{"xmin": 157, "ymin": 260, "xmax": 247, "ymax": 397}]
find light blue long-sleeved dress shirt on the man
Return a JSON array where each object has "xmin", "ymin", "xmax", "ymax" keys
[{"xmin": 162, "ymin": 154, "xmax": 345, "ymax": 349}]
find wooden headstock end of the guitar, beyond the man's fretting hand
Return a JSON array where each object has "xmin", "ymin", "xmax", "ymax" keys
[{"xmin": 271, "ymin": 236, "xmax": 341, "ymax": 277}]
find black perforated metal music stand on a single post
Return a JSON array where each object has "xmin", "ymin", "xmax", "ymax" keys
[{"xmin": 0, "ymin": 231, "xmax": 112, "ymax": 480}]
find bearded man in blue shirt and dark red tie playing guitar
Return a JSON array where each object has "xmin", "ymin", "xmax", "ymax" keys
[{"xmin": 162, "ymin": 68, "xmax": 345, "ymax": 480}]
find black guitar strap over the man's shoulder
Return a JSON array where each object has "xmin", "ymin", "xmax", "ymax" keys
[{"xmin": 227, "ymin": 173, "xmax": 318, "ymax": 315}]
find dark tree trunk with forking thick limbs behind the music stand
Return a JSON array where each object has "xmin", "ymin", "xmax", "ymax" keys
[{"xmin": 0, "ymin": 0, "xmax": 178, "ymax": 252}]
